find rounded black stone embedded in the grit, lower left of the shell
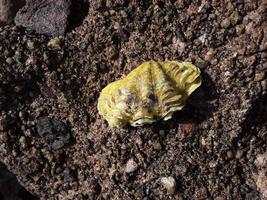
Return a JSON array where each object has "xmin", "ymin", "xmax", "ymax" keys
[{"xmin": 36, "ymin": 117, "xmax": 70, "ymax": 150}]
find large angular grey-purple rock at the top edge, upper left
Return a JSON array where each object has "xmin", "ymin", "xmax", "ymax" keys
[{"xmin": 15, "ymin": 0, "xmax": 72, "ymax": 36}]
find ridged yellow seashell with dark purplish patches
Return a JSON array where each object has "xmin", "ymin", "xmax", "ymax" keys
[{"xmin": 97, "ymin": 61, "xmax": 201, "ymax": 127}]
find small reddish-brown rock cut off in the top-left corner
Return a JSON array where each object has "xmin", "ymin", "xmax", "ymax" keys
[{"xmin": 0, "ymin": 0, "xmax": 25, "ymax": 26}]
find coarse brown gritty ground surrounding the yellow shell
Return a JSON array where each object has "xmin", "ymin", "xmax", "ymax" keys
[{"xmin": 0, "ymin": 0, "xmax": 267, "ymax": 200}]
